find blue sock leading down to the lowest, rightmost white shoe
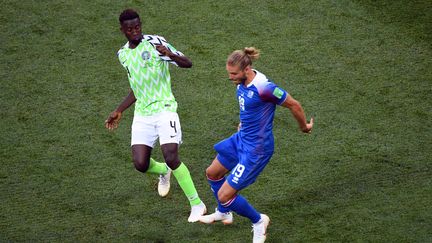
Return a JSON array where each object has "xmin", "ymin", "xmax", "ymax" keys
[{"xmin": 218, "ymin": 195, "xmax": 261, "ymax": 224}]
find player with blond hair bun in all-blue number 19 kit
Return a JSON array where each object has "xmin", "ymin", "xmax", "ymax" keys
[{"xmin": 200, "ymin": 47, "xmax": 313, "ymax": 243}]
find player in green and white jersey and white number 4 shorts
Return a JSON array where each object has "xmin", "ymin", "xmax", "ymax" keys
[{"xmin": 105, "ymin": 9, "xmax": 207, "ymax": 222}]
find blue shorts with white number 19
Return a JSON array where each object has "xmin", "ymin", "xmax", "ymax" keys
[{"xmin": 214, "ymin": 133, "xmax": 273, "ymax": 191}]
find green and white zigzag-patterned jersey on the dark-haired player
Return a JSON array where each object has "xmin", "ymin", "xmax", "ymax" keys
[{"xmin": 117, "ymin": 35, "xmax": 183, "ymax": 116}]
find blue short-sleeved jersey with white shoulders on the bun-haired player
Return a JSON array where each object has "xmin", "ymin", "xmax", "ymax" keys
[{"xmin": 237, "ymin": 70, "xmax": 288, "ymax": 154}]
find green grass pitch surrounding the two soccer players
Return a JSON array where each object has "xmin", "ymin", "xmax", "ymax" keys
[{"xmin": 0, "ymin": 0, "xmax": 432, "ymax": 242}]
